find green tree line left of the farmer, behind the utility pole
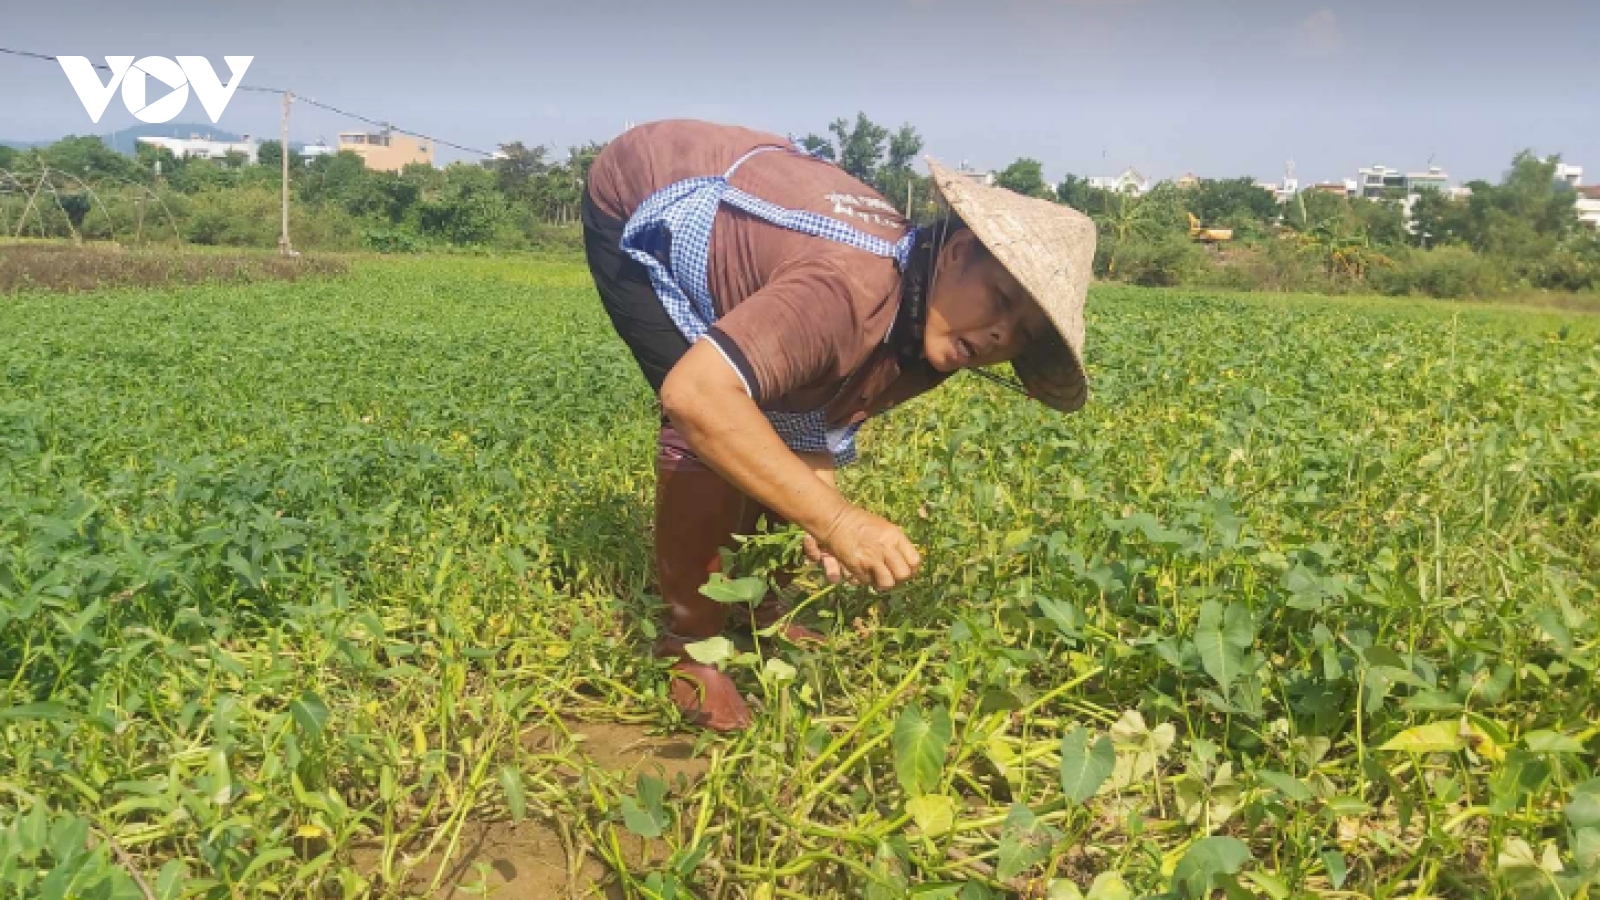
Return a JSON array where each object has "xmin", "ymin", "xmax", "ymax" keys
[{"xmin": 0, "ymin": 136, "xmax": 603, "ymax": 251}]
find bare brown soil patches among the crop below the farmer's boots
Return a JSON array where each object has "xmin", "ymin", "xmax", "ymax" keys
[{"xmin": 355, "ymin": 722, "xmax": 709, "ymax": 900}]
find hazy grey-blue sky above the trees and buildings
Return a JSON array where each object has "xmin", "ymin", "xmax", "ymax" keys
[{"xmin": 0, "ymin": 0, "xmax": 1600, "ymax": 183}]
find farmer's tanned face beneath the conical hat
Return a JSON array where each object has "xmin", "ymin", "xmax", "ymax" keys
[{"xmin": 922, "ymin": 231, "xmax": 1050, "ymax": 372}]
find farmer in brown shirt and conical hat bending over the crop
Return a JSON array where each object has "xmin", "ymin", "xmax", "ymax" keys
[{"xmin": 582, "ymin": 122, "xmax": 1094, "ymax": 730}]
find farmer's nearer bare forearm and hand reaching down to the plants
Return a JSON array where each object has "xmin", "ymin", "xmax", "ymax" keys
[{"xmin": 661, "ymin": 340, "xmax": 922, "ymax": 591}]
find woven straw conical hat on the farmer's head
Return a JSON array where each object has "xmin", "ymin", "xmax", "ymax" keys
[{"xmin": 928, "ymin": 157, "xmax": 1096, "ymax": 413}]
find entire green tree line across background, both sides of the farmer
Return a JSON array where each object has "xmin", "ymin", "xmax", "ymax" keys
[{"xmin": 0, "ymin": 112, "xmax": 1600, "ymax": 296}]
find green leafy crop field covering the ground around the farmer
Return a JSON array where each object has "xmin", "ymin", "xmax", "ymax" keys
[{"xmin": 0, "ymin": 259, "xmax": 1600, "ymax": 900}]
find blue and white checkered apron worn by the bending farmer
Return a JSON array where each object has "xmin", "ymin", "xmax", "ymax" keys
[{"xmin": 622, "ymin": 146, "xmax": 917, "ymax": 466}]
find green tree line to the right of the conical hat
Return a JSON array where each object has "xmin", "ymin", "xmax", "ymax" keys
[{"xmin": 1054, "ymin": 152, "xmax": 1600, "ymax": 298}]
